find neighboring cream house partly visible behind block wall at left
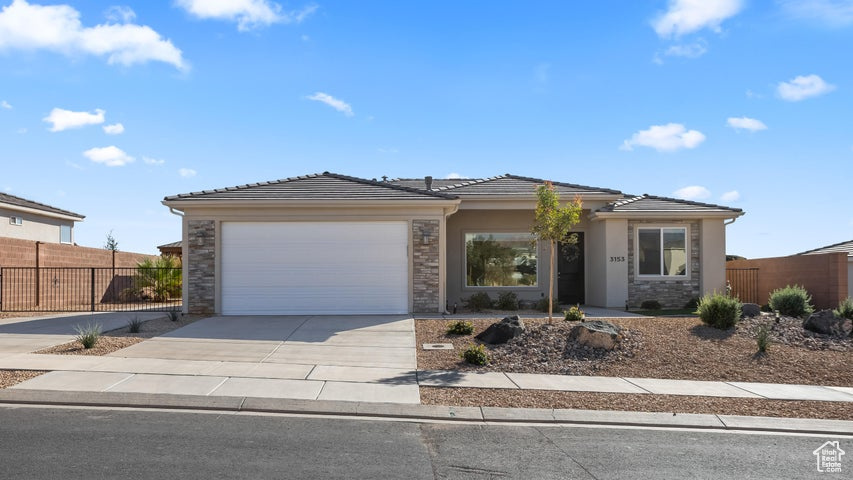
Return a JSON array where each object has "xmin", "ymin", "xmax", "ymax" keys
[{"xmin": 0, "ymin": 193, "xmax": 85, "ymax": 244}]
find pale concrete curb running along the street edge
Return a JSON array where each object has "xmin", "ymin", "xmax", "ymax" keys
[{"xmin": 0, "ymin": 389, "xmax": 853, "ymax": 436}]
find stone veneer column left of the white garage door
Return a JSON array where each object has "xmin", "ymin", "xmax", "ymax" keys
[{"xmin": 185, "ymin": 220, "xmax": 216, "ymax": 315}]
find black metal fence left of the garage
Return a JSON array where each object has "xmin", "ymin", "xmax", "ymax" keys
[{"xmin": 0, "ymin": 267, "xmax": 181, "ymax": 312}]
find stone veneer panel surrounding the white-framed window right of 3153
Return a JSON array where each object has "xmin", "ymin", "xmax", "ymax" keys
[{"xmin": 628, "ymin": 221, "xmax": 701, "ymax": 308}]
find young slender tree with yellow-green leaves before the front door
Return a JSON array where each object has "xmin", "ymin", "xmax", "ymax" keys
[{"xmin": 531, "ymin": 182, "xmax": 583, "ymax": 322}]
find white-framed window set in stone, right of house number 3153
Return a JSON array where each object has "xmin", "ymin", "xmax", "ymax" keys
[{"xmin": 637, "ymin": 228, "xmax": 687, "ymax": 277}]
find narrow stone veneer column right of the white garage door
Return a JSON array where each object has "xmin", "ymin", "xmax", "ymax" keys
[{"xmin": 412, "ymin": 220, "xmax": 441, "ymax": 312}]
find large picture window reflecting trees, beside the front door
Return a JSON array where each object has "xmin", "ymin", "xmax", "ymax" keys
[{"xmin": 465, "ymin": 233, "xmax": 536, "ymax": 287}]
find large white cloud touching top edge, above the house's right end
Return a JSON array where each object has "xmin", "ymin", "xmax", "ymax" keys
[{"xmin": 652, "ymin": 0, "xmax": 743, "ymax": 37}]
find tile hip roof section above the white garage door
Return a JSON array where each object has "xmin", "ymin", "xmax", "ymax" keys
[{"xmin": 165, "ymin": 172, "xmax": 456, "ymax": 201}]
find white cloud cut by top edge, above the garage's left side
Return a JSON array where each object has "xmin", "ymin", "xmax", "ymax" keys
[{"xmin": 177, "ymin": 0, "xmax": 317, "ymax": 32}]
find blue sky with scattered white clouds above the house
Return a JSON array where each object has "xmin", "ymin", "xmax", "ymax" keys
[{"xmin": 0, "ymin": 0, "xmax": 853, "ymax": 258}]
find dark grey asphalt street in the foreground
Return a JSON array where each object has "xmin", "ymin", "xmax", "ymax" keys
[{"xmin": 0, "ymin": 406, "xmax": 853, "ymax": 479}]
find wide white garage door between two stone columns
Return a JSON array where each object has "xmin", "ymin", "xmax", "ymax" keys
[{"xmin": 220, "ymin": 222, "xmax": 409, "ymax": 315}]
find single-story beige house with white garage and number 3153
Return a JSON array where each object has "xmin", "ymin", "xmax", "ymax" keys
[{"xmin": 163, "ymin": 172, "xmax": 743, "ymax": 315}]
